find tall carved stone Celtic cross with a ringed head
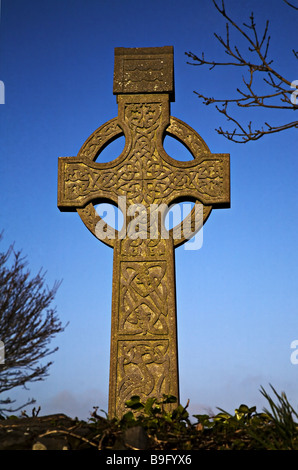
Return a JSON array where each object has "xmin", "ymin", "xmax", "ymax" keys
[{"xmin": 58, "ymin": 46, "xmax": 230, "ymax": 417}]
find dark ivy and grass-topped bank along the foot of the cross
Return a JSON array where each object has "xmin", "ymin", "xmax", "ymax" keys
[{"xmin": 0, "ymin": 387, "xmax": 298, "ymax": 452}]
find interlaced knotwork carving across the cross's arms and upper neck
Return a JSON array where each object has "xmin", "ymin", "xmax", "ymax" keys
[{"xmin": 65, "ymin": 111, "xmax": 225, "ymax": 208}]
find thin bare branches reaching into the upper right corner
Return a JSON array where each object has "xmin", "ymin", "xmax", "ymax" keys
[{"xmin": 186, "ymin": 0, "xmax": 298, "ymax": 143}]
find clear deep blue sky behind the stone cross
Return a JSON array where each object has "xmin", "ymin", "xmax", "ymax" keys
[{"xmin": 0, "ymin": 0, "xmax": 298, "ymax": 419}]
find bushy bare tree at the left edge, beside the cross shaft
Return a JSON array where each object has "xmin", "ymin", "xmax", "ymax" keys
[{"xmin": 0, "ymin": 235, "xmax": 65, "ymax": 416}]
